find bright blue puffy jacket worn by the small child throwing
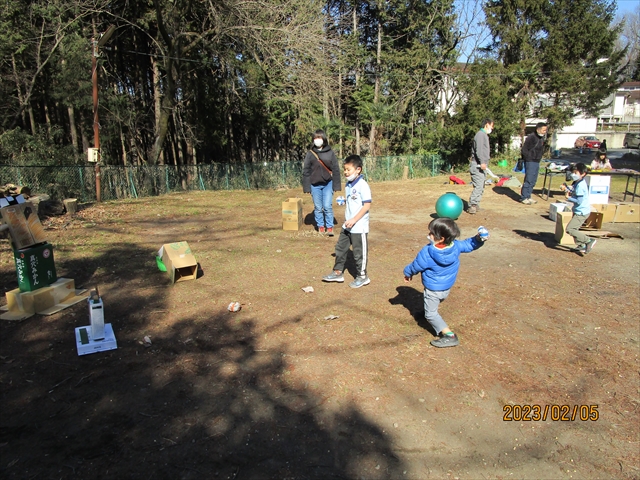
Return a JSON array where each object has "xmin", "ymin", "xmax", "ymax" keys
[{"xmin": 404, "ymin": 236, "xmax": 484, "ymax": 292}]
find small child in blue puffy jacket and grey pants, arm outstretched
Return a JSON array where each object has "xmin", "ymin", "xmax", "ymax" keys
[{"xmin": 404, "ymin": 218, "xmax": 488, "ymax": 347}]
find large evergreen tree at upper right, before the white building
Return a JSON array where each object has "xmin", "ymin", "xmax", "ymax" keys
[{"xmin": 485, "ymin": 0, "xmax": 624, "ymax": 131}]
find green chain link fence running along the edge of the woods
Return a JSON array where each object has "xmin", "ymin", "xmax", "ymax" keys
[{"xmin": 0, "ymin": 155, "xmax": 445, "ymax": 202}]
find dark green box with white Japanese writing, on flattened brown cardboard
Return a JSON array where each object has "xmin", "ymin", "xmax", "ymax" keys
[{"xmin": 13, "ymin": 243, "xmax": 58, "ymax": 292}]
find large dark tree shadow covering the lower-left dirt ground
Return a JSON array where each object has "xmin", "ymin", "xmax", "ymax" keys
[{"xmin": 0, "ymin": 246, "xmax": 403, "ymax": 479}]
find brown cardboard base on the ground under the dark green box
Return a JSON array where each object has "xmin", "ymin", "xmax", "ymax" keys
[{"xmin": 0, "ymin": 278, "xmax": 88, "ymax": 320}]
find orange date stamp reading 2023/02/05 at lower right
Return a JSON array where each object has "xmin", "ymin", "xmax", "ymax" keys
[{"xmin": 502, "ymin": 404, "xmax": 600, "ymax": 422}]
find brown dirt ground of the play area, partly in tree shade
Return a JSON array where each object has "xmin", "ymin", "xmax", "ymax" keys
[{"xmin": 0, "ymin": 163, "xmax": 640, "ymax": 479}]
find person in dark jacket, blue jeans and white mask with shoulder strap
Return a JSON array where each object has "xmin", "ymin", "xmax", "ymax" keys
[{"xmin": 302, "ymin": 130, "xmax": 342, "ymax": 237}]
